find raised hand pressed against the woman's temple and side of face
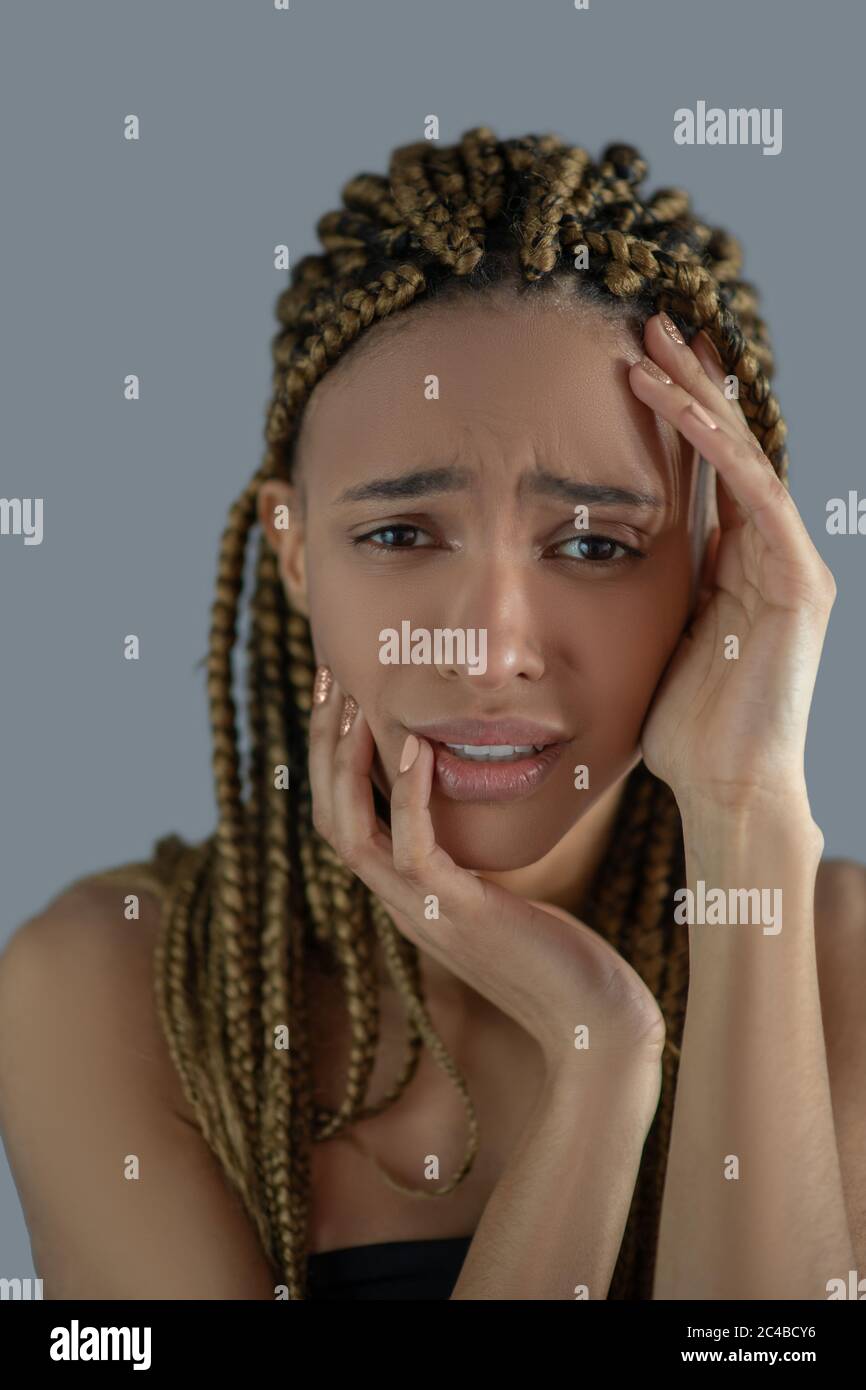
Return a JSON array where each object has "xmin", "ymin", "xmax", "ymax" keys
[{"xmin": 628, "ymin": 316, "xmax": 835, "ymax": 809}]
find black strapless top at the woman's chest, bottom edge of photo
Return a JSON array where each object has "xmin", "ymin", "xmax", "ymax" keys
[{"xmin": 307, "ymin": 1236, "xmax": 473, "ymax": 1300}]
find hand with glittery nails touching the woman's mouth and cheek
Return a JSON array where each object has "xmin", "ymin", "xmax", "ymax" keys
[{"xmin": 310, "ymin": 669, "xmax": 666, "ymax": 1076}]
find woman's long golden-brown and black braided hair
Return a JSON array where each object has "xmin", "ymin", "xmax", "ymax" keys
[{"xmin": 130, "ymin": 126, "xmax": 787, "ymax": 1298}]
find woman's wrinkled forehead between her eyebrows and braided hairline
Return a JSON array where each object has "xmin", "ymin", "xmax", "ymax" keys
[{"xmin": 297, "ymin": 296, "xmax": 683, "ymax": 488}]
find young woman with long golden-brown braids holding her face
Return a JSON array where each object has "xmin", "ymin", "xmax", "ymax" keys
[{"xmin": 0, "ymin": 128, "xmax": 866, "ymax": 1300}]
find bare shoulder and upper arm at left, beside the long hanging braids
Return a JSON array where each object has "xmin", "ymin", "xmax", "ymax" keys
[{"xmin": 0, "ymin": 876, "xmax": 274, "ymax": 1298}]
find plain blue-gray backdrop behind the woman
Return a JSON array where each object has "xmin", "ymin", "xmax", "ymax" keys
[{"xmin": 0, "ymin": 0, "xmax": 866, "ymax": 1277}]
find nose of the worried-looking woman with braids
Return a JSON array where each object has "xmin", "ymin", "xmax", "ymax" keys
[{"xmin": 435, "ymin": 556, "xmax": 545, "ymax": 695}]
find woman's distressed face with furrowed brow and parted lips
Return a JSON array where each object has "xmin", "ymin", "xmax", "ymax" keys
[{"xmin": 260, "ymin": 299, "xmax": 699, "ymax": 870}]
